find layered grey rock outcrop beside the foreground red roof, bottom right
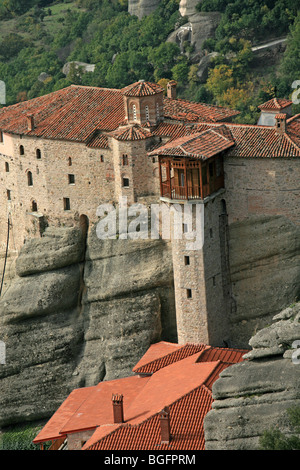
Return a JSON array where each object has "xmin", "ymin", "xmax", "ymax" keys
[{"xmin": 204, "ymin": 303, "xmax": 300, "ymax": 450}]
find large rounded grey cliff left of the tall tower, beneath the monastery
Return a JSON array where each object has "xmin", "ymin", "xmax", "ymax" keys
[{"xmin": 0, "ymin": 228, "xmax": 176, "ymax": 427}]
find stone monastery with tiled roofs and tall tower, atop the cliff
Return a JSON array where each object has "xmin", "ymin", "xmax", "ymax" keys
[{"xmin": 0, "ymin": 80, "xmax": 300, "ymax": 346}]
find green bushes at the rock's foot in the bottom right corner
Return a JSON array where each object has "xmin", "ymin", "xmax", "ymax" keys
[{"xmin": 260, "ymin": 407, "xmax": 300, "ymax": 450}]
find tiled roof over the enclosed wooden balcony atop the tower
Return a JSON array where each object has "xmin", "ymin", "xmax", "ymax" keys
[{"xmin": 150, "ymin": 126, "xmax": 235, "ymax": 160}]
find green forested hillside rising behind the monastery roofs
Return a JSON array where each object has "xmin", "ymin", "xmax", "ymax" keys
[{"xmin": 0, "ymin": 0, "xmax": 300, "ymax": 122}]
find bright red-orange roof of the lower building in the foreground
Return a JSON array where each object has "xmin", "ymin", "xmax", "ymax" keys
[{"xmin": 33, "ymin": 342, "xmax": 247, "ymax": 450}]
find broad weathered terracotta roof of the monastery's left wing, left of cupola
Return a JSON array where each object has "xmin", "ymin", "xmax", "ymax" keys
[{"xmin": 0, "ymin": 85, "xmax": 125, "ymax": 142}]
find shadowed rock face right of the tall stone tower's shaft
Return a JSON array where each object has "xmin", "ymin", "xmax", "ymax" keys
[{"xmin": 229, "ymin": 216, "xmax": 300, "ymax": 348}]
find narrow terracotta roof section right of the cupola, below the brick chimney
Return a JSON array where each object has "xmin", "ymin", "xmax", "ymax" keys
[{"xmin": 164, "ymin": 98, "xmax": 240, "ymax": 122}]
